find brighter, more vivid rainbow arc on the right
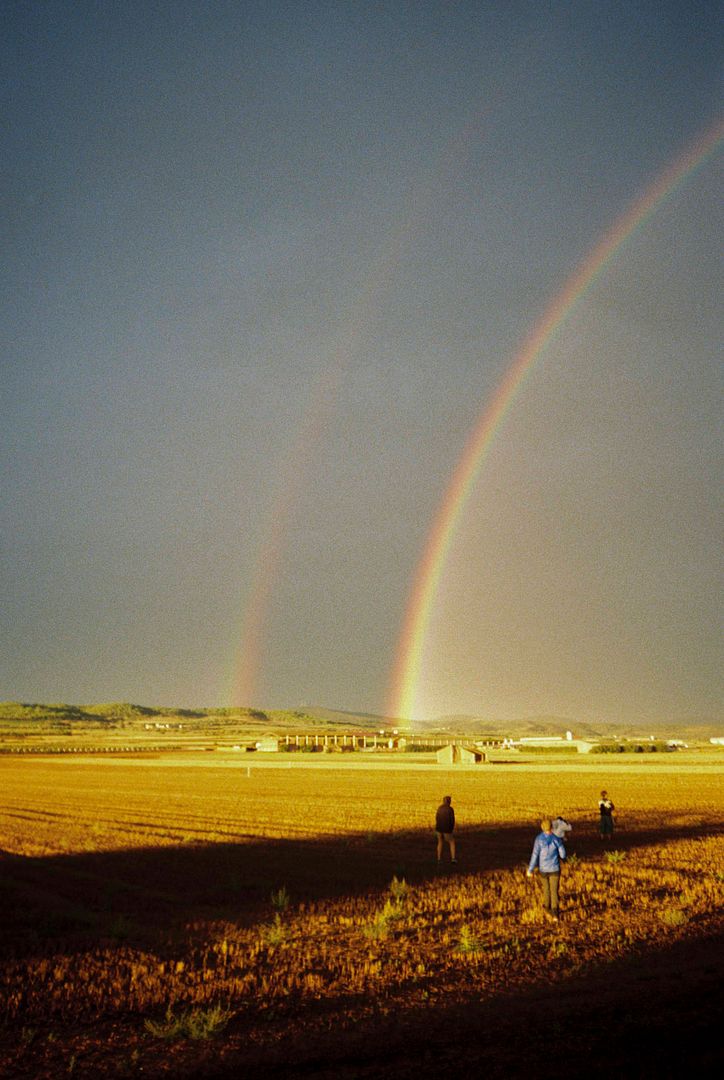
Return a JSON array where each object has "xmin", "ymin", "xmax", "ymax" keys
[{"xmin": 388, "ymin": 120, "xmax": 724, "ymax": 720}]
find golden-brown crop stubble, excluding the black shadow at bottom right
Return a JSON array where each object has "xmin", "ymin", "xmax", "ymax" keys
[{"xmin": 0, "ymin": 759, "xmax": 722, "ymax": 1075}]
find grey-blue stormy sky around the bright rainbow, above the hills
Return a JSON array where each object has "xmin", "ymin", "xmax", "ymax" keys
[{"xmin": 0, "ymin": 0, "xmax": 724, "ymax": 723}]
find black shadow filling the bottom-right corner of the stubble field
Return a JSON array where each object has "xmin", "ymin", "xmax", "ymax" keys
[{"xmin": 221, "ymin": 934, "xmax": 724, "ymax": 1080}]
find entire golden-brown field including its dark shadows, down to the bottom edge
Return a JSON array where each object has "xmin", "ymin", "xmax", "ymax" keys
[{"xmin": 0, "ymin": 754, "xmax": 724, "ymax": 1080}]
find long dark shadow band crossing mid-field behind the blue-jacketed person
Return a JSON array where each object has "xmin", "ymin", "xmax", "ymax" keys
[{"xmin": 0, "ymin": 815, "xmax": 722, "ymax": 958}]
